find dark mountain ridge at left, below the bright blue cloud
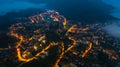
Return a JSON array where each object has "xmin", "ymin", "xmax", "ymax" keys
[{"xmin": 0, "ymin": 8, "xmax": 44, "ymax": 31}]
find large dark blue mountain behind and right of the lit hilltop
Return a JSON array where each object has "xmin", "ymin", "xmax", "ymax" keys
[{"xmin": 44, "ymin": 0, "xmax": 118, "ymax": 23}]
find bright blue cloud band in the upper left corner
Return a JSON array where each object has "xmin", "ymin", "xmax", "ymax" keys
[{"xmin": 0, "ymin": 0, "xmax": 46, "ymax": 15}]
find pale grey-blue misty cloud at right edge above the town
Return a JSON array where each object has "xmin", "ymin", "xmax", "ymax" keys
[{"xmin": 104, "ymin": 24, "xmax": 120, "ymax": 38}]
